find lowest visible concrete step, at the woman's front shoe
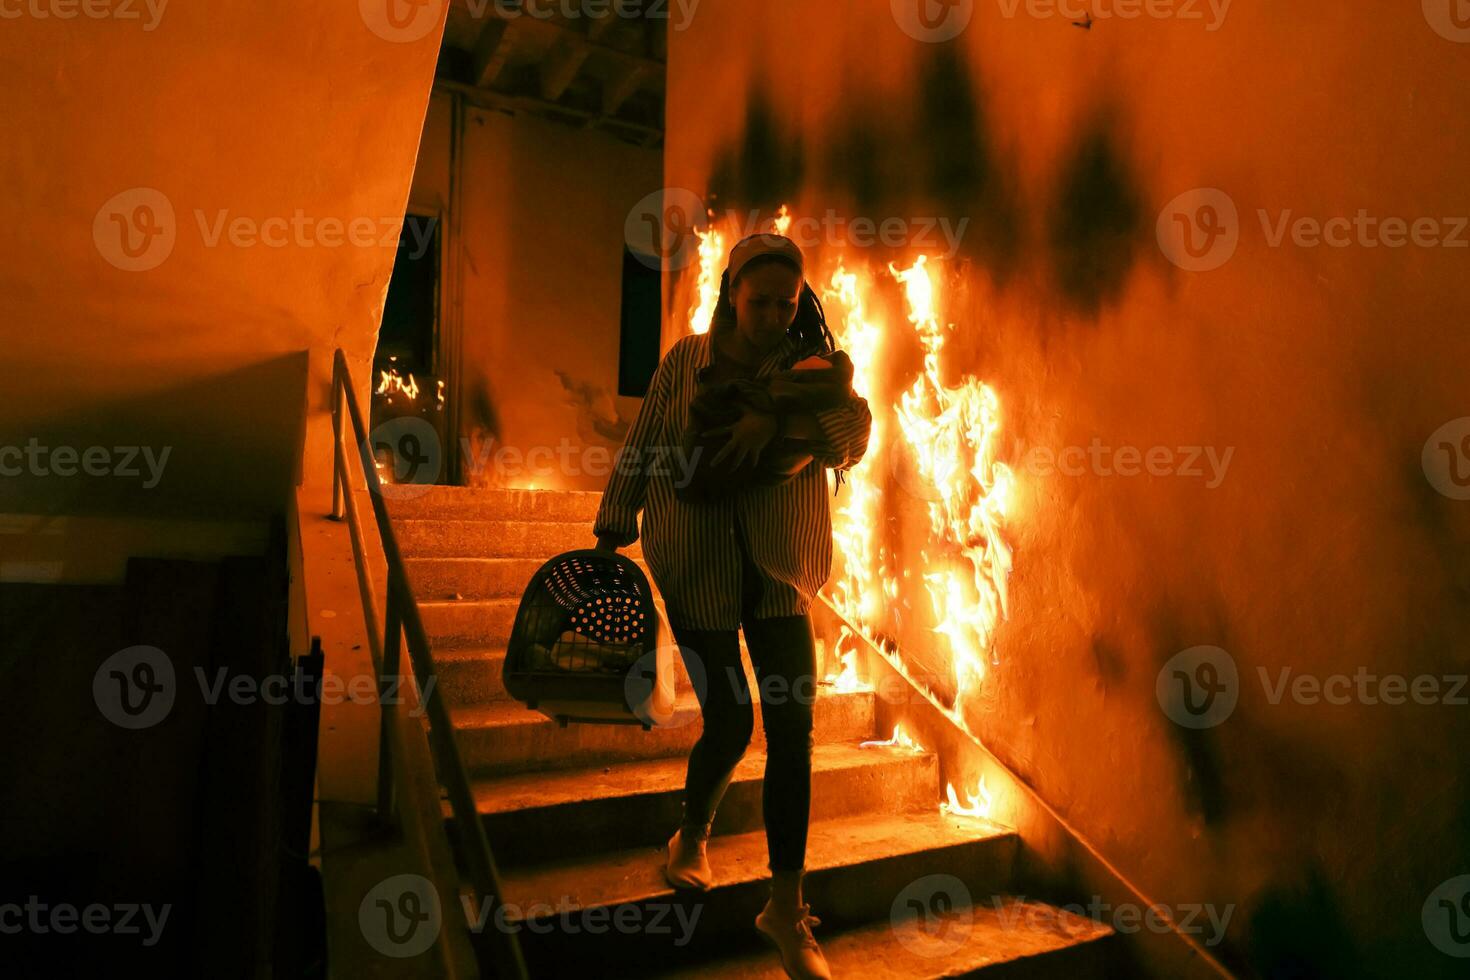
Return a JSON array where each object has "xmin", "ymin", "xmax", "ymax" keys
[{"xmin": 650, "ymin": 895, "xmax": 1117, "ymax": 980}]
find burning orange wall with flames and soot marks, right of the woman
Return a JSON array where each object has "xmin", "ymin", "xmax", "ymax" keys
[{"xmin": 664, "ymin": 1, "xmax": 1470, "ymax": 976}]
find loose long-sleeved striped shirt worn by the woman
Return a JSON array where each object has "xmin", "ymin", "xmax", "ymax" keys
[{"xmin": 592, "ymin": 328, "xmax": 873, "ymax": 629}]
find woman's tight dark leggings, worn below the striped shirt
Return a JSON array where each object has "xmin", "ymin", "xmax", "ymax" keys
[{"xmin": 673, "ymin": 520, "xmax": 816, "ymax": 871}]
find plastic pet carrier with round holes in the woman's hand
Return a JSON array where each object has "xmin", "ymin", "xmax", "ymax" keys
[{"xmin": 504, "ymin": 550, "xmax": 675, "ymax": 729}]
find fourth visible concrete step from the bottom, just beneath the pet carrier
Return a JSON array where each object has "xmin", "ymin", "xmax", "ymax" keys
[{"xmin": 451, "ymin": 691, "xmax": 875, "ymax": 776}]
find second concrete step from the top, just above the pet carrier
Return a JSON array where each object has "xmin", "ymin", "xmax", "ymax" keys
[{"xmin": 394, "ymin": 519, "xmax": 642, "ymax": 561}]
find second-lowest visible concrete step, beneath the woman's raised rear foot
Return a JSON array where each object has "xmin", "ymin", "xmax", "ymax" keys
[{"xmin": 487, "ymin": 810, "xmax": 1017, "ymax": 977}]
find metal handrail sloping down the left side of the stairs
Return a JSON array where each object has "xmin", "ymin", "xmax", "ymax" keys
[{"xmin": 332, "ymin": 348, "xmax": 528, "ymax": 980}]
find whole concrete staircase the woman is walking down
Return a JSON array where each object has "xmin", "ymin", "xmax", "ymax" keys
[{"xmin": 391, "ymin": 488, "xmax": 1116, "ymax": 980}]
